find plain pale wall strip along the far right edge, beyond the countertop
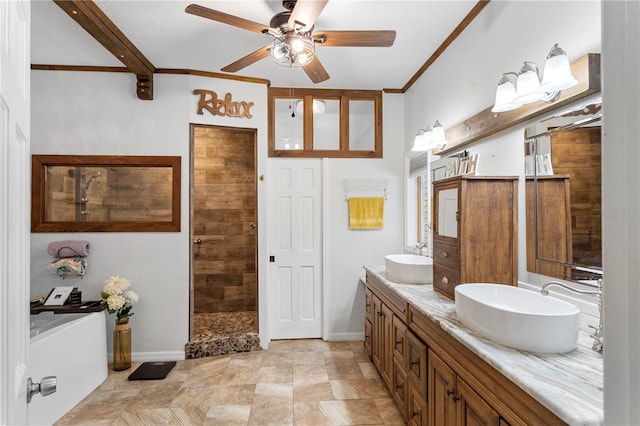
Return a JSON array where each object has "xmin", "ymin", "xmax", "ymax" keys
[{"xmin": 602, "ymin": 1, "xmax": 640, "ymax": 425}]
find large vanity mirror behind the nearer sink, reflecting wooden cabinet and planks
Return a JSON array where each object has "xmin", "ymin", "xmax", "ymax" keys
[{"xmin": 525, "ymin": 98, "xmax": 602, "ymax": 283}]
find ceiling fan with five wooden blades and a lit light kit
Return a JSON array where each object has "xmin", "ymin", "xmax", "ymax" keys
[{"xmin": 185, "ymin": 0, "xmax": 396, "ymax": 83}]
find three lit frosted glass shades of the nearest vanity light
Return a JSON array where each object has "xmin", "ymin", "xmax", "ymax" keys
[{"xmin": 491, "ymin": 43, "xmax": 578, "ymax": 112}]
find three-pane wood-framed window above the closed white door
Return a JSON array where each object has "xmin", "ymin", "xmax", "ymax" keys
[{"xmin": 269, "ymin": 87, "xmax": 382, "ymax": 158}]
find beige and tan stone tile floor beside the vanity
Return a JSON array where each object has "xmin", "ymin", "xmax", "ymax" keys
[{"xmin": 56, "ymin": 340, "xmax": 405, "ymax": 426}]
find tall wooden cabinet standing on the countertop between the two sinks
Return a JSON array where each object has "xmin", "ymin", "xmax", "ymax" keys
[{"xmin": 433, "ymin": 176, "xmax": 518, "ymax": 298}]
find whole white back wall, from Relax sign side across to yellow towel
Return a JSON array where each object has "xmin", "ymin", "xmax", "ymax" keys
[{"xmin": 31, "ymin": 71, "xmax": 404, "ymax": 352}]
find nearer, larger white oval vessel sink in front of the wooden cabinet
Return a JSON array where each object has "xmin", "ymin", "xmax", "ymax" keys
[{"xmin": 455, "ymin": 283, "xmax": 580, "ymax": 353}]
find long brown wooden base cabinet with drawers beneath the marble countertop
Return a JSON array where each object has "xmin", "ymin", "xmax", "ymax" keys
[{"xmin": 365, "ymin": 272, "xmax": 565, "ymax": 426}]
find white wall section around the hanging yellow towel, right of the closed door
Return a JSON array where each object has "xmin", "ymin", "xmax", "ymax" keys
[{"xmin": 324, "ymin": 94, "xmax": 404, "ymax": 340}]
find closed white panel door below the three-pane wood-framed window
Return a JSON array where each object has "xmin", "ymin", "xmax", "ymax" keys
[{"xmin": 269, "ymin": 159, "xmax": 322, "ymax": 339}]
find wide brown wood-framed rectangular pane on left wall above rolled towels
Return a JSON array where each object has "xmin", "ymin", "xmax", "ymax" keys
[{"xmin": 31, "ymin": 155, "xmax": 181, "ymax": 232}]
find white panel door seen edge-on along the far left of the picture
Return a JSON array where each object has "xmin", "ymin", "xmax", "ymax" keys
[{"xmin": 0, "ymin": 1, "xmax": 30, "ymax": 424}]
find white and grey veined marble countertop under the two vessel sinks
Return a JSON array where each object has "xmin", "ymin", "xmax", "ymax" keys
[{"xmin": 365, "ymin": 266, "xmax": 604, "ymax": 425}]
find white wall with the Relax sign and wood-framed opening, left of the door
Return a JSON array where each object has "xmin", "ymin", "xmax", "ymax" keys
[{"xmin": 31, "ymin": 71, "xmax": 267, "ymax": 360}]
